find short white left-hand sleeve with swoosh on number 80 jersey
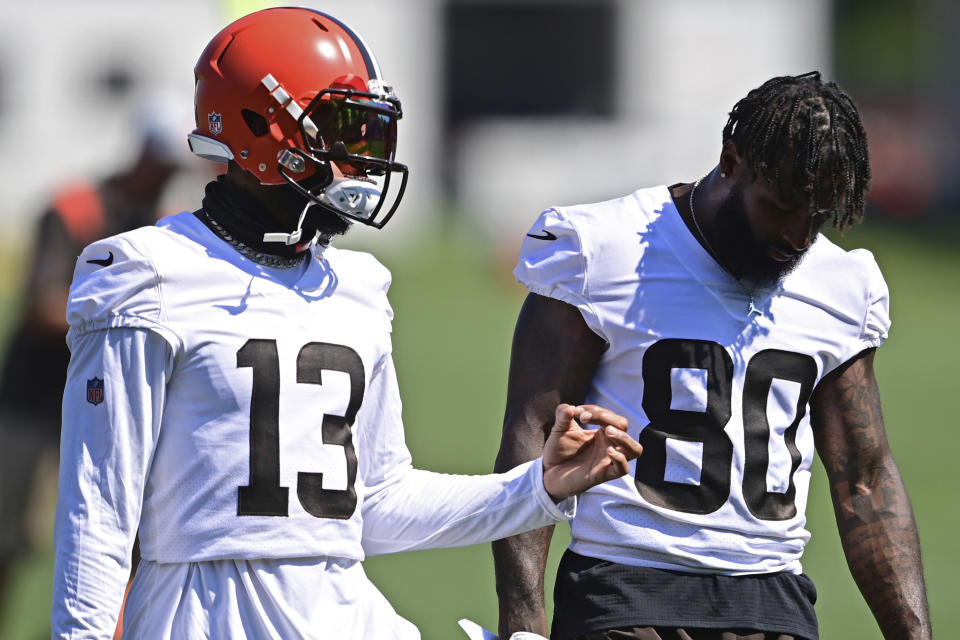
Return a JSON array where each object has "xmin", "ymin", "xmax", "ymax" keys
[{"xmin": 513, "ymin": 209, "xmax": 604, "ymax": 337}]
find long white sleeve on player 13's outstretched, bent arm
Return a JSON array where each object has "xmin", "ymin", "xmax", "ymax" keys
[{"xmin": 357, "ymin": 357, "xmax": 576, "ymax": 555}]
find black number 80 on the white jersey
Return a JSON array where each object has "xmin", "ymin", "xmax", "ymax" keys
[{"xmin": 635, "ymin": 339, "xmax": 817, "ymax": 520}]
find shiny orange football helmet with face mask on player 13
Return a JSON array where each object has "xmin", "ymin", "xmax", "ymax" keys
[{"xmin": 188, "ymin": 7, "xmax": 408, "ymax": 229}]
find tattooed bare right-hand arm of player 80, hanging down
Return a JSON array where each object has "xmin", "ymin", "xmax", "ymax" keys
[{"xmin": 811, "ymin": 349, "xmax": 931, "ymax": 639}]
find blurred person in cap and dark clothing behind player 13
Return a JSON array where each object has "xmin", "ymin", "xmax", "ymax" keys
[{"xmin": 0, "ymin": 94, "xmax": 190, "ymax": 602}]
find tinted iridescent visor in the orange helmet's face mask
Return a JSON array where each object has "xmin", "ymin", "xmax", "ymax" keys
[{"xmin": 306, "ymin": 94, "xmax": 397, "ymax": 162}]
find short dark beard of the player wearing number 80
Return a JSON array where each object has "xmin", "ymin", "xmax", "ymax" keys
[{"xmin": 713, "ymin": 184, "xmax": 806, "ymax": 287}]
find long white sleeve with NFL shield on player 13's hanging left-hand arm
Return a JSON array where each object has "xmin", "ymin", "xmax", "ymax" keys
[{"xmin": 51, "ymin": 328, "xmax": 173, "ymax": 639}]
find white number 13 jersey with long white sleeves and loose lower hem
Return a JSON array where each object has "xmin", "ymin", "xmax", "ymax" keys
[{"xmin": 53, "ymin": 213, "xmax": 574, "ymax": 638}]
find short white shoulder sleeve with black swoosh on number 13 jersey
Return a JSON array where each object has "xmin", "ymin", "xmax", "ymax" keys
[{"xmin": 67, "ymin": 234, "xmax": 180, "ymax": 346}]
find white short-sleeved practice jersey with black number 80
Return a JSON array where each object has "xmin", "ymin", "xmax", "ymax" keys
[{"xmin": 515, "ymin": 186, "xmax": 890, "ymax": 575}]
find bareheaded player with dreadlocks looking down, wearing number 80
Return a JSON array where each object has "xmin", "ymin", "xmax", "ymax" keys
[{"xmin": 494, "ymin": 72, "xmax": 930, "ymax": 640}]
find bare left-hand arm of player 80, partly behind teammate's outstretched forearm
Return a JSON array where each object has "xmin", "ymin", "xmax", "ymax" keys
[{"xmin": 493, "ymin": 294, "xmax": 605, "ymax": 638}]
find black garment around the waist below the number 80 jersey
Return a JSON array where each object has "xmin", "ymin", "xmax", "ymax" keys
[{"xmin": 550, "ymin": 550, "xmax": 818, "ymax": 640}]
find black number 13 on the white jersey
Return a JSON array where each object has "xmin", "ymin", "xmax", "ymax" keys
[{"xmin": 237, "ymin": 339, "xmax": 364, "ymax": 519}]
